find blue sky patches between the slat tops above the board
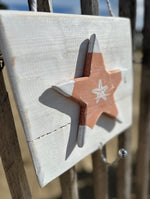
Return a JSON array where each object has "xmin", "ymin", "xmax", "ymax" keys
[{"xmin": 0, "ymin": 0, "xmax": 143, "ymax": 29}]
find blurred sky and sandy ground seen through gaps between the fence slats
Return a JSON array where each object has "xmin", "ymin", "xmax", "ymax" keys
[{"xmin": 0, "ymin": 0, "xmax": 146, "ymax": 199}]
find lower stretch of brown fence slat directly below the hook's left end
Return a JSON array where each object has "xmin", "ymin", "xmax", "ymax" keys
[{"xmin": 92, "ymin": 150, "xmax": 108, "ymax": 199}]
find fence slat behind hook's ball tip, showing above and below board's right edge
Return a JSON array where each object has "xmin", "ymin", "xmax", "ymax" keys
[{"xmin": 117, "ymin": 0, "xmax": 136, "ymax": 199}]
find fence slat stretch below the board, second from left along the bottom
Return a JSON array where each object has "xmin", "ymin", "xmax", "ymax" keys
[{"xmin": 60, "ymin": 167, "xmax": 79, "ymax": 199}]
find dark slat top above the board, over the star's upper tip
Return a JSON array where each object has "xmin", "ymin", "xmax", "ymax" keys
[{"xmin": 80, "ymin": 0, "xmax": 99, "ymax": 15}]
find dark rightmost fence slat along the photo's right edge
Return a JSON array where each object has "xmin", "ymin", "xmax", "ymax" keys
[{"xmin": 136, "ymin": 0, "xmax": 150, "ymax": 199}]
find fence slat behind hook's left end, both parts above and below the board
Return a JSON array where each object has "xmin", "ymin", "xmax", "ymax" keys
[{"xmin": 80, "ymin": 0, "xmax": 108, "ymax": 199}]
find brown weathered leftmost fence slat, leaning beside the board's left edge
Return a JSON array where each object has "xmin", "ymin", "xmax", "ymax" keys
[{"xmin": 0, "ymin": 71, "xmax": 31, "ymax": 199}]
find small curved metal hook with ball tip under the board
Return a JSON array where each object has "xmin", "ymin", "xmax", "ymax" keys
[{"xmin": 100, "ymin": 143, "xmax": 128, "ymax": 165}]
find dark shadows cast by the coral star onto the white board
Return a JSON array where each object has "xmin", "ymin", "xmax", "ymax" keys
[{"xmin": 39, "ymin": 39, "xmax": 115, "ymax": 160}]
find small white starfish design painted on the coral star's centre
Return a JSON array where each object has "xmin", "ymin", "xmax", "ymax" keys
[{"xmin": 92, "ymin": 80, "xmax": 108, "ymax": 103}]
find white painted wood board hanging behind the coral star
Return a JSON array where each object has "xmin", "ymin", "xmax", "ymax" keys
[{"xmin": 0, "ymin": 11, "xmax": 133, "ymax": 186}]
